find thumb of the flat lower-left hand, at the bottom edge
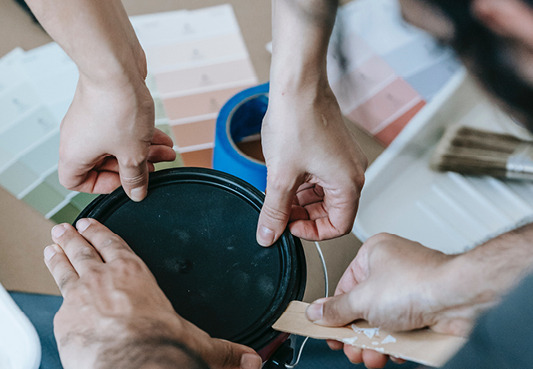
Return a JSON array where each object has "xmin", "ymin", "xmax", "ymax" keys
[{"xmin": 202, "ymin": 339, "xmax": 263, "ymax": 369}]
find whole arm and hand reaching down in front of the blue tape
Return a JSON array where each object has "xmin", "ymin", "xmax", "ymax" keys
[{"xmin": 257, "ymin": 0, "xmax": 367, "ymax": 246}]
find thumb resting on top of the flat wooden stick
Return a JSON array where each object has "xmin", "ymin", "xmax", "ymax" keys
[{"xmin": 306, "ymin": 287, "xmax": 364, "ymax": 327}]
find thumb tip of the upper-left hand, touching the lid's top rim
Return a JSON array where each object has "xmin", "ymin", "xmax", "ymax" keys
[{"xmin": 118, "ymin": 158, "xmax": 149, "ymax": 201}]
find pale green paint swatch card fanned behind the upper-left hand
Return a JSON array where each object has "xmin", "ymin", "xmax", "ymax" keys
[{"xmin": 0, "ymin": 43, "xmax": 180, "ymax": 223}]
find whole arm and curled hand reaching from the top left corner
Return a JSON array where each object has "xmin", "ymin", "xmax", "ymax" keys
[{"xmin": 27, "ymin": 0, "xmax": 175, "ymax": 201}]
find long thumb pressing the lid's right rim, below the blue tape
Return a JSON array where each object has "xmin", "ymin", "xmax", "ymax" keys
[{"xmin": 256, "ymin": 172, "xmax": 298, "ymax": 246}]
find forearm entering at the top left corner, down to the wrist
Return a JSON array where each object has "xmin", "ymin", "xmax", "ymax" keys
[{"xmin": 27, "ymin": 0, "xmax": 146, "ymax": 84}]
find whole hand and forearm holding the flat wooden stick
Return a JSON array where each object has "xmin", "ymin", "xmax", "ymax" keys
[{"xmin": 307, "ymin": 224, "xmax": 533, "ymax": 368}]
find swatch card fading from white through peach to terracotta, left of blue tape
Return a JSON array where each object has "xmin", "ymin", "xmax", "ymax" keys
[{"xmin": 132, "ymin": 5, "xmax": 257, "ymax": 167}]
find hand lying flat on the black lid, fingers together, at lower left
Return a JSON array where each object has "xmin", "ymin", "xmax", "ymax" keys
[{"xmin": 44, "ymin": 219, "xmax": 261, "ymax": 369}]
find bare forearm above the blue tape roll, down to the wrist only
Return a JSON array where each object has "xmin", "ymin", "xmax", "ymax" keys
[{"xmin": 270, "ymin": 0, "xmax": 338, "ymax": 91}]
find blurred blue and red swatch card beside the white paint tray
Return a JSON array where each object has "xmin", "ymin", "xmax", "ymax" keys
[{"xmin": 328, "ymin": 0, "xmax": 461, "ymax": 145}]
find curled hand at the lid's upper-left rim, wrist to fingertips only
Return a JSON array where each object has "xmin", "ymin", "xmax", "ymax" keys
[{"xmin": 58, "ymin": 74, "xmax": 176, "ymax": 201}]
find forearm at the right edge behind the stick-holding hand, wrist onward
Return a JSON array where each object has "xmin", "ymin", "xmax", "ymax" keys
[{"xmin": 444, "ymin": 224, "xmax": 533, "ymax": 304}]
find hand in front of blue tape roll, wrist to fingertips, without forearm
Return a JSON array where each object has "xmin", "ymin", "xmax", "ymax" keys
[{"xmin": 257, "ymin": 81, "xmax": 367, "ymax": 246}]
